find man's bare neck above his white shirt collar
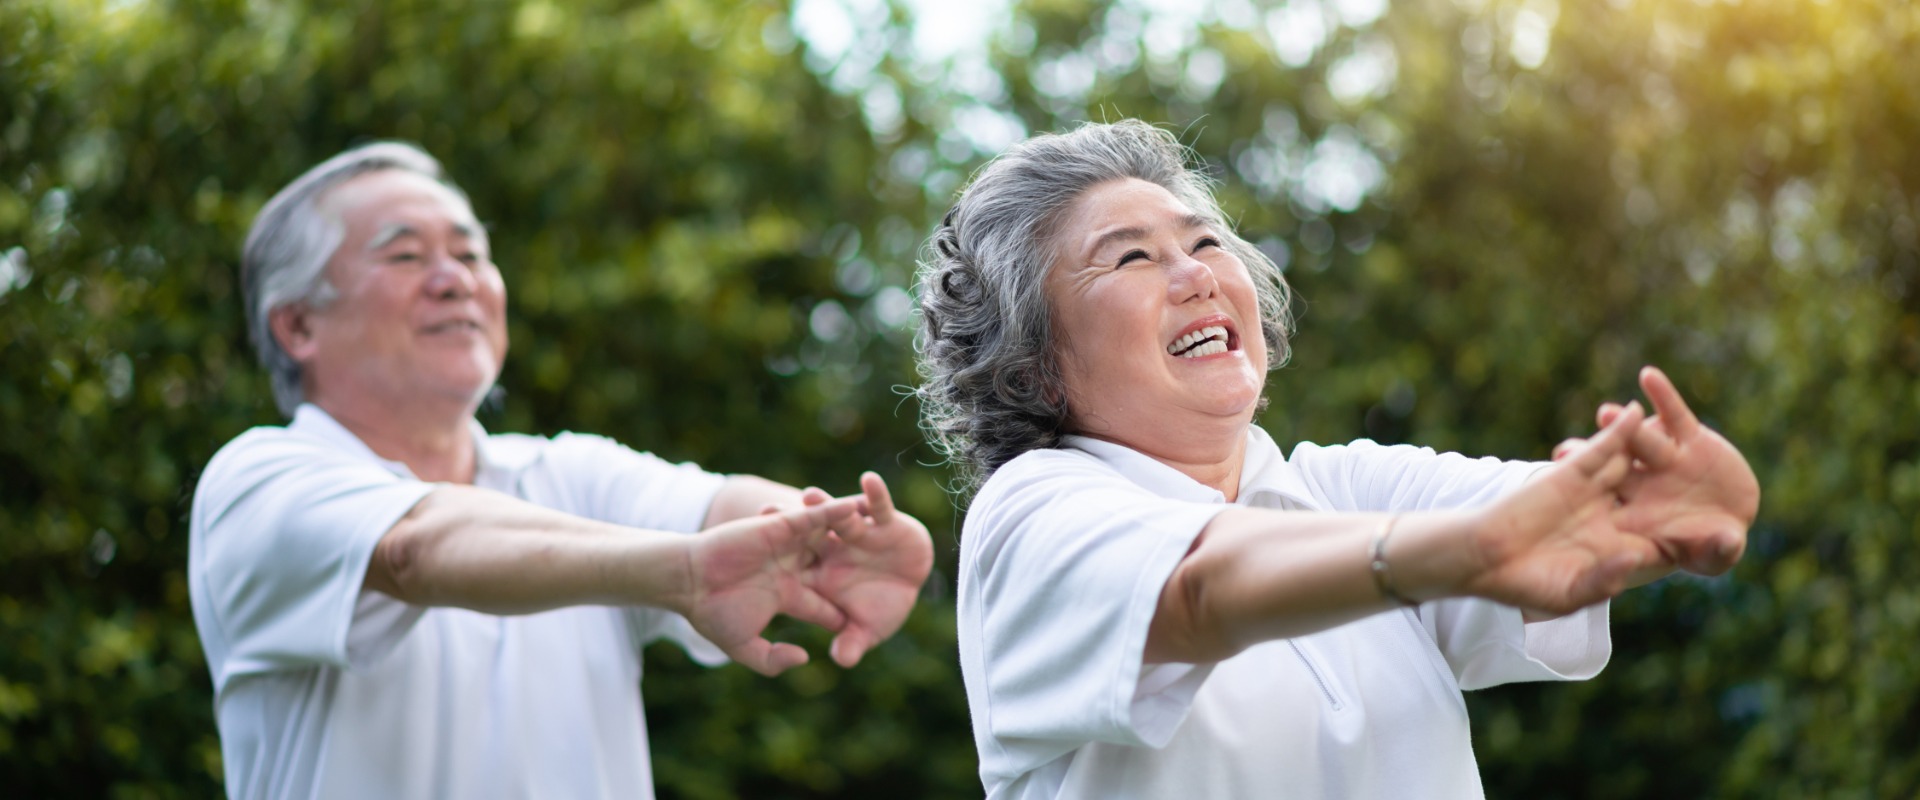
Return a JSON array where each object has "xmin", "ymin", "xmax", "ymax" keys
[{"xmin": 313, "ymin": 397, "xmax": 478, "ymax": 483}]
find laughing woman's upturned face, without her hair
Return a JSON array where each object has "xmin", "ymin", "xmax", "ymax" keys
[{"xmin": 1046, "ymin": 178, "xmax": 1267, "ymax": 455}]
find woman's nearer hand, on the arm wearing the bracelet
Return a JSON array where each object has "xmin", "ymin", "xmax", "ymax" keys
[{"xmin": 1463, "ymin": 403, "xmax": 1663, "ymax": 616}]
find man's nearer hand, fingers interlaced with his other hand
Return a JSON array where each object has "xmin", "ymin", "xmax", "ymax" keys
[{"xmin": 676, "ymin": 489, "xmax": 864, "ymax": 675}]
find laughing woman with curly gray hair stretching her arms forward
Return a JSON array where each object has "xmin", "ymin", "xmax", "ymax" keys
[{"xmin": 920, "ymin": 121, "xmax": 1759, "ymax": 798}]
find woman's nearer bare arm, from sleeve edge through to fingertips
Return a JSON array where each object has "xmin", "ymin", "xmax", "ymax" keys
[{"xmin": 1144, "ymin": 403, "xmax": 1663, "ymax": 662}]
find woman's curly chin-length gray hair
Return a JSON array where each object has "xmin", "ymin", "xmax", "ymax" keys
[{"xmin": 916, "ymin": 119, "xmax": 1290, "ymax": 491}]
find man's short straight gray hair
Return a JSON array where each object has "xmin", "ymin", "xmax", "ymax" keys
[{"xmin": 240, "ymin": 142, "xmax": 467, "ymax": 416}]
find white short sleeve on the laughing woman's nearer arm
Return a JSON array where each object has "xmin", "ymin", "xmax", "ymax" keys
[{"xmin": 960, "ymin": 451, "xmax": 1225, "ymax": 775}]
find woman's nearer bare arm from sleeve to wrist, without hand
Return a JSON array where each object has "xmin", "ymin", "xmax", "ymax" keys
[{"xmin": 1146, "ymin": 508, "xmax": 1478, "ymax": 662}]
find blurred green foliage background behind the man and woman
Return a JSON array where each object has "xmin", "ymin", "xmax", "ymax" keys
[{"xmin": 0, "ymin": 0, "xmax": 1920, "ymax": 798}]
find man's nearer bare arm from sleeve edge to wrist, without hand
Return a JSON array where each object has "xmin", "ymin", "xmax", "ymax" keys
[{"xmin": 367, "ymin": 485, "xmax": 693, "ymax": 614}]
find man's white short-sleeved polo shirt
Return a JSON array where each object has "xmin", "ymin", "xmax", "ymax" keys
[{"xmin": 188, "ymin": 405, "xmax": 724, "ymax": 800}]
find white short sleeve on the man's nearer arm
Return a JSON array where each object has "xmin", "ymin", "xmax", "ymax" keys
[{"xmin": 188, "ymin": 430, "xmax": 432, "ymax": 689}]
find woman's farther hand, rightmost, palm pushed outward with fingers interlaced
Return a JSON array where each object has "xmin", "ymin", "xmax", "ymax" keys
[{"xmin": 1553, "ymin": 366, "xmax": 1761, "ymax": 583}]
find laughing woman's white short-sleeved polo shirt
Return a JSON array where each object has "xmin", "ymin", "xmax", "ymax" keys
[{"xmin": 960, "ymin": 428, "xmax": 1611, "ymax": 800}]
